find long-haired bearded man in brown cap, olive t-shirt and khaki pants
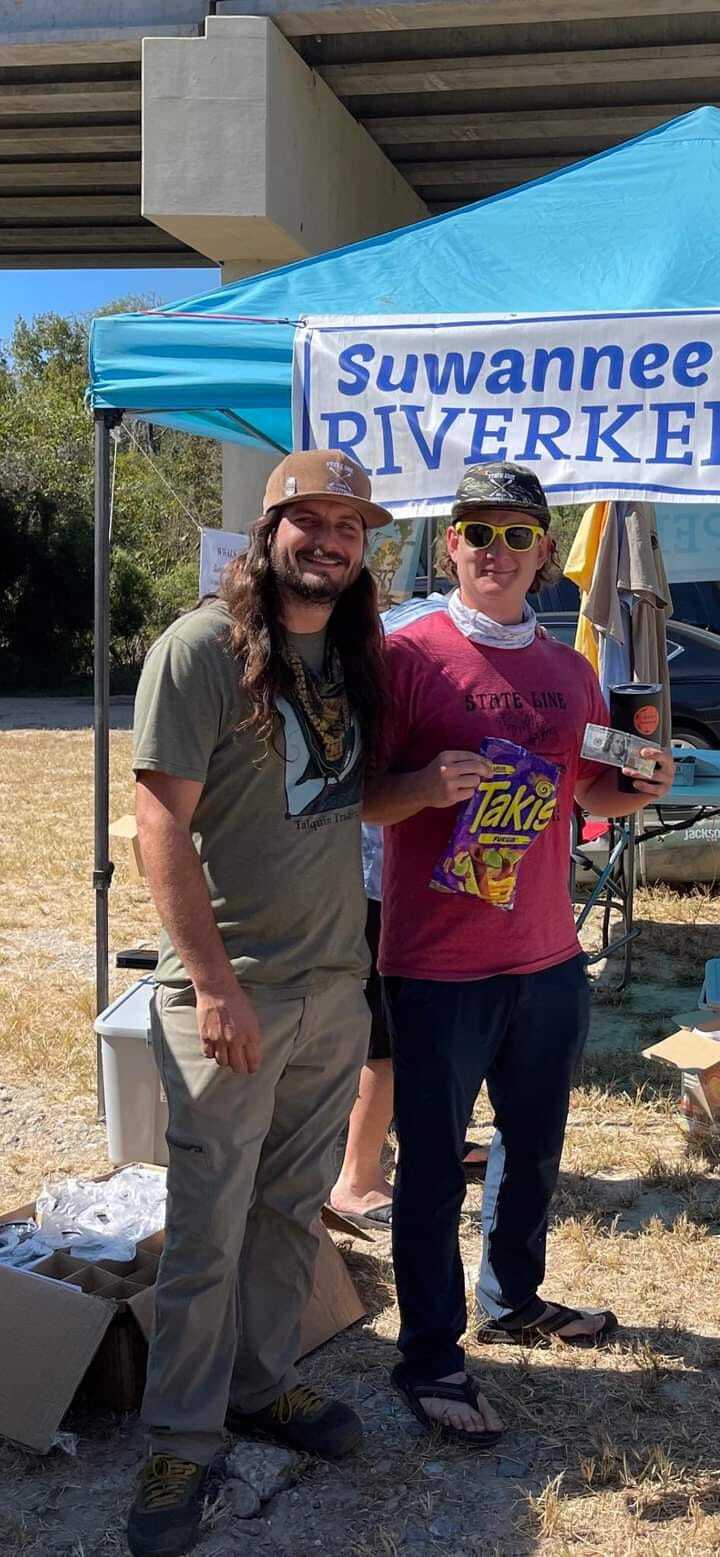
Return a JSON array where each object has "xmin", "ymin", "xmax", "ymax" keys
[{"xmin": 128, "ymin": 452, "xmax": 390, "ymax": 1557}]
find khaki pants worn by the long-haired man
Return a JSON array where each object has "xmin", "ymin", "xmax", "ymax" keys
[{"xmin": 142, "ymin": 976, "xmax": 369, "ymax": 1464}]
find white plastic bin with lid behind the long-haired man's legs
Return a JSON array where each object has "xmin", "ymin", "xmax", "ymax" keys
[{"xmin": 95, "ymin": 978, "xmax": 167, "ymax": 1168}]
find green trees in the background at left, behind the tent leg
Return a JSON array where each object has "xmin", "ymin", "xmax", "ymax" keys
[{"xmin": 0, "ymin": 297, "xmax": 221, "ymax": 688}]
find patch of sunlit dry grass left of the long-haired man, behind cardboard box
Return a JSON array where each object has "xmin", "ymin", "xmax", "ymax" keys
[{"xmin": 0, "ymin": 730, "xmax": 157, "ymax": 1205}]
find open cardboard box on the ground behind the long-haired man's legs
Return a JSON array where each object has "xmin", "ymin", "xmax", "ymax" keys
[{"xmin": 0, "ymin": 1174, "xmax": 366, "ymax": 1454}]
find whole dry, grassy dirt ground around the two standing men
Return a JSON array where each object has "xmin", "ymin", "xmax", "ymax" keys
[{"xmin": 0, "ymin": 699, "xmax": 720, "ymax": 1557}]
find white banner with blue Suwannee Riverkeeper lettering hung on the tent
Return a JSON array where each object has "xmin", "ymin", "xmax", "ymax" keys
[{"xmin": 293, "ymin": 309, "xmax": 720, "ymax": 517}]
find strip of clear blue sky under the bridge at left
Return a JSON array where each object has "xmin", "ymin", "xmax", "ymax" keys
[{"xmin": 0, "ymin": 266, "xmax": 220, "ymax": 343}]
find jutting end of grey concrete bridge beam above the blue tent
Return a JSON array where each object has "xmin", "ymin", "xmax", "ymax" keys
[{"xmin": 142, "ymin": 17, "xmax": 427, "ymax": 274}]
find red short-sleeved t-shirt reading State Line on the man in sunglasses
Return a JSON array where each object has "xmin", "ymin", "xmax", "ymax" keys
[{"xmin": 379, "ymin": 612, "xmax": 609, "ymax": 979}]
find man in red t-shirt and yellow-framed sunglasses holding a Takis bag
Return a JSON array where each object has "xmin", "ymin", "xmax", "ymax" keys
[{"xmin": 366, "ymin": 464, "xmax": 673, "ymax": 1446}]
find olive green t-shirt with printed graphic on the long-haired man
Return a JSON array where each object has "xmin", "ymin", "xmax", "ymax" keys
[{"xmin": 132, "ymin": 601, "xmax": 368, "ymax": 995}]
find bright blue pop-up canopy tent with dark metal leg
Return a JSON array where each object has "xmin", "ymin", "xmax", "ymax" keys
[{"xmin": 89, "ymin": 107, "xmax": 720, "ymax": 1058}]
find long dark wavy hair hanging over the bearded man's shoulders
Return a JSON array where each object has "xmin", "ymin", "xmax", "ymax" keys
[{"xmin": 220, "ymin": 514, "xmax": 386, "ymax": 771}]
